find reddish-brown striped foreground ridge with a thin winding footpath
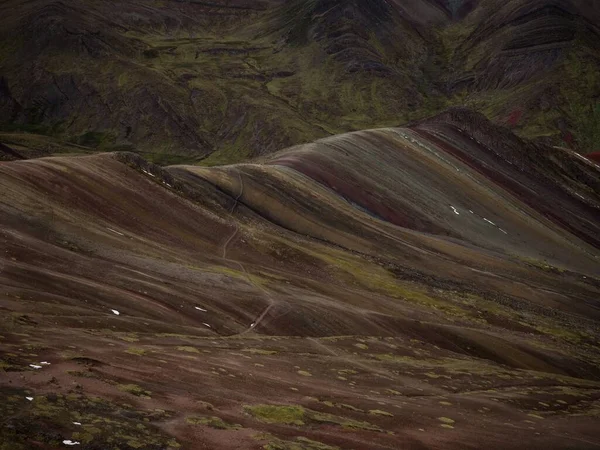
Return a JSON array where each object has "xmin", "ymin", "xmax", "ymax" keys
[{"xmin": 0, "ymin": 108, "xmax": 600, "ymax": 450}]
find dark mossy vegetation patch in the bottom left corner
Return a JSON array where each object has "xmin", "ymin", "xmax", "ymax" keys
[{"xmin": 0, "ymin": 388, "xmax": 180, "ymax": 450}]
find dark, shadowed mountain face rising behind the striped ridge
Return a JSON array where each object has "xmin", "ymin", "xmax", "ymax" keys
[{"xmin": 0, "ymin": 0, "xmax": 600, "ymax": 164}]
